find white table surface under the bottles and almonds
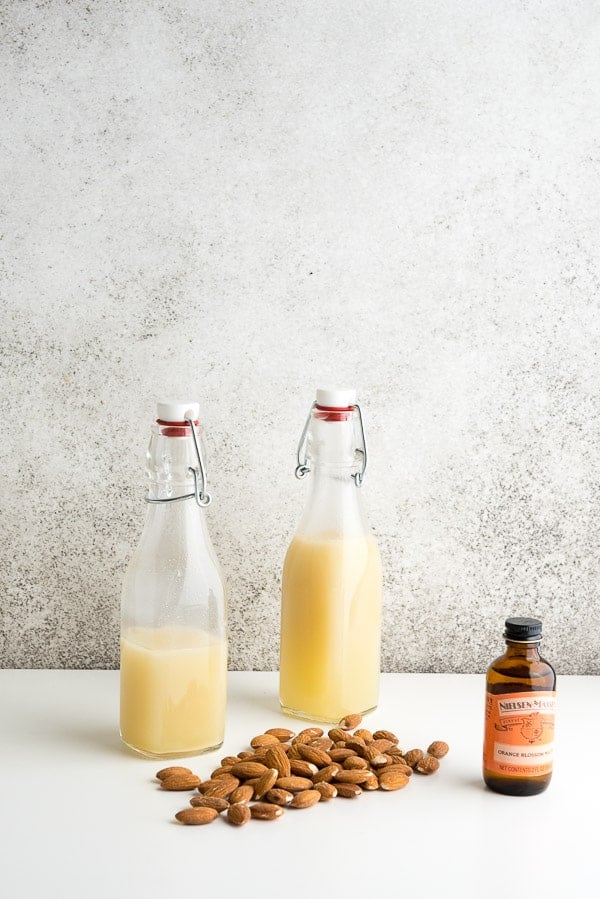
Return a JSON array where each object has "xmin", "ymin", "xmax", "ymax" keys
[{"xmin": 0, "ymin": 670, "xmax": 600, "ymax": 899}]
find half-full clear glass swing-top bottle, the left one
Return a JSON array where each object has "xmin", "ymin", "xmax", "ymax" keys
[{"xmin": 120, "ymin": 402, "xmax": 227, "ymax": 758}]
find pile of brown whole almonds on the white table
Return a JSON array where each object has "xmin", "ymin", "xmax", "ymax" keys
[{"xmin": 156, "ymin": 715, "xmax": 448, "ymax": 826}]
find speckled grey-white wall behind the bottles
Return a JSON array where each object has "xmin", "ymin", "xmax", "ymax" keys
[{"xmin": 0, "ymin": 0, "xmax": 600, "ymax": 674}]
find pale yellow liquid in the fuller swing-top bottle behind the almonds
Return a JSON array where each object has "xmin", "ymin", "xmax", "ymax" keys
[{"xmin": 279, "ymin": 537, "xmax": 381, "ymax": 722}]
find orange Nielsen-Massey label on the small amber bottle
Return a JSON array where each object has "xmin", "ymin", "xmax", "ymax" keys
[{"xmin": 483, "ymin": 690, "xmax": 556, "ymax": 777}]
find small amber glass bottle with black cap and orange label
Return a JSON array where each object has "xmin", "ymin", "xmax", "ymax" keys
[{"xmin": 483, "ymin": 618, "xmax": 556, "ymax": 796}]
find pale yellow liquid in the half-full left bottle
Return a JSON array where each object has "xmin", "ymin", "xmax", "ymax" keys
[{"xmin": 121, "ymin": 628, "xmax": 227, "ymax": 757}]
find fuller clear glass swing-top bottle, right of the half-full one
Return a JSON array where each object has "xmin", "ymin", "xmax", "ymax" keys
[{"xmin": 279, "ymin": 389, "xmax": 382, "ymax": 722}]
